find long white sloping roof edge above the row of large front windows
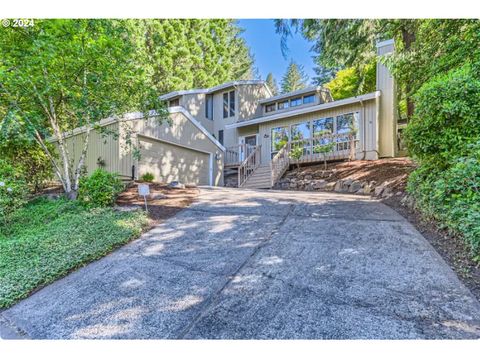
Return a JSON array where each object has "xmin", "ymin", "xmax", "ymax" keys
[{"xmin": 225, "ymin": 91, "xmax": 380, "ymax": 129}]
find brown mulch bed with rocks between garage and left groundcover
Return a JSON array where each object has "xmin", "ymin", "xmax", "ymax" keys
[{"xmin": 117, "ymin": 183, "xmax": 200, "ymax": 226}]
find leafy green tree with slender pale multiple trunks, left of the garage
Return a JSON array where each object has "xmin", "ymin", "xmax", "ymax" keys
[{"xmin": 0, "ymin": 20, "xmax": 163, "ymax": 199}]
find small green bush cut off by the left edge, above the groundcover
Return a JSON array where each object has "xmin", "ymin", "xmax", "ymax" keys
[{"xmin": 0, "ymin": 160, "xmax": 28, "ymax": 222}]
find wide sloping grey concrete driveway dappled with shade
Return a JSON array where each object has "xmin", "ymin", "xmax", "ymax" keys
[{"xmin": 0, "ymin": 189, "xmax": 480, "ymax": 339}]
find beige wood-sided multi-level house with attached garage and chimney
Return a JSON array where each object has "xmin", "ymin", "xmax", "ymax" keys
[{"xmin": 58, "ymin": 40, "xmax": 398, "ymax": 188}]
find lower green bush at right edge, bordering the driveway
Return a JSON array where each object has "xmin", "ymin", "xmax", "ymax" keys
[{"xmin": 407, "ymin": 141, "xmax": 480, "ymax": 254}]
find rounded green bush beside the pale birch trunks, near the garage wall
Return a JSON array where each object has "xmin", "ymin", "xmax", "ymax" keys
[{"xmin": 78, "ymin": 169, "xmax": 123, "ymax": 207}]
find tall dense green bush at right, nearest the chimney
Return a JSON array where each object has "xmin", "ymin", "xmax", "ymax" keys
[{"xmin": 405, "ymin": 64, "xmax": 480, "ymax": 169}]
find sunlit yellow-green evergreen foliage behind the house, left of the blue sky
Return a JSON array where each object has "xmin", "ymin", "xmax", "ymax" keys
[{"xmin": 131, "ymin": 19, "xmax": 254, "ymax": 93}]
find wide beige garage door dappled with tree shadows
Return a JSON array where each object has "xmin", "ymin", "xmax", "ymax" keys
[{"xmin": 138, "ymin": 136, "xmax": 210, "ymax": 185}]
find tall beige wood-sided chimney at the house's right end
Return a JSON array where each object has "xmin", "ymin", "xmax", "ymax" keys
[{"xmin": 376, "ymin": 39, "xmax": 397, "ymax": 157}]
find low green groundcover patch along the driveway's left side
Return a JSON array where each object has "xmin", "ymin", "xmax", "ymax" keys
[{"xmin": 0, "ymin": 198, "xmax": 147, "ymax": 308}]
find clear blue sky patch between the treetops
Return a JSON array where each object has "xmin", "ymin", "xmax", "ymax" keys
[{"xmin": 238, "ymin": 19, "xmax": 315, "ymax": 84}]
